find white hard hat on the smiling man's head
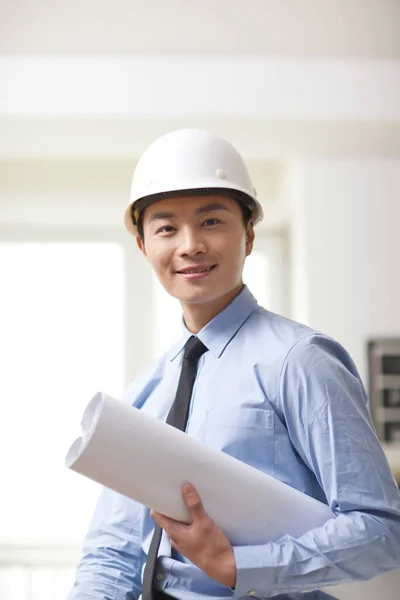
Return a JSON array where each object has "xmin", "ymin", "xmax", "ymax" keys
[{"xmin": 124, "ymin": 129, "xmax": 263, "ymax": 235}]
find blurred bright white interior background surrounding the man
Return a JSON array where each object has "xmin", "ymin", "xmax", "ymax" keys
[{"xmin": 0, "ymin": 0, "xmax": 400, "ymax": 600}]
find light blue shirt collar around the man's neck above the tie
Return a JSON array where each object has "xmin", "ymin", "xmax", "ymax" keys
[{"xmin": 167, "ymin": 286, "xmax": 257, "ymax": 361}]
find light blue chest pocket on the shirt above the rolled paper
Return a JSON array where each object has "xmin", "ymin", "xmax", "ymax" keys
[{"xmin": 204, "ymin": 408, "xmax": 275, "ymax": 475}]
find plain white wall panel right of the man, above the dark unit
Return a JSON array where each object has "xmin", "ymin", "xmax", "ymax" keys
[{"xmin": 291, "ymin": 159, "xmax": 400, "ymax": 379}]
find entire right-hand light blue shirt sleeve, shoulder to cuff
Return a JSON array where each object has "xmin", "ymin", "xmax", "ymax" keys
[{"xmin": 234, "ymin": 334, "xmax": 400, "ymax": 598}]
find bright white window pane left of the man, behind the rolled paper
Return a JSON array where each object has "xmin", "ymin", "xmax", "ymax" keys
[{"xmin": 0, "ymin": 242, "xmax": 125, "ymax": 543}]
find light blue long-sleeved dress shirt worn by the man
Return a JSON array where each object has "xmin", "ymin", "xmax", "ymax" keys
[{"xmin": 69, "ymin": 287, "xmax": 400, "ymax": 600}]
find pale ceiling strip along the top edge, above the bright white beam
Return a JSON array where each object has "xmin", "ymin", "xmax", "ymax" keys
[{"xmin": 0, "ymin": 0, "xmax": 400, "ymax": 58}]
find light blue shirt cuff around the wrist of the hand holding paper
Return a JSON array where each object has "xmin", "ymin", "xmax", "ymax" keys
[{"xmin": 233, "ymin": 545, "xmax": 274, "ymax": 598}]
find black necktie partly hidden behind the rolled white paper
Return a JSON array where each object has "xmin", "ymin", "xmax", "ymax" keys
[{"xmin": 142, "ymin": 336, "xmax": 208, "ymax": 600}]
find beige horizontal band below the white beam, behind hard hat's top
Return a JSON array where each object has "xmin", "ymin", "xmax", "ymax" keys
[{"xmin": 0, "ymin": 118, "xmax": 400, "ymax": 161}]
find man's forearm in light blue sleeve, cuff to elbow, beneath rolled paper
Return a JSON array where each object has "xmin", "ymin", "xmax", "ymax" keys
[{"xmin": 234, "ymin": 512, "xmax": 400, "ymax": 598}]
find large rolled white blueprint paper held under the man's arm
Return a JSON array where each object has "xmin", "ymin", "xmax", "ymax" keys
[{"xmin": 65, "ymin": 393, "xmax": 400, "ymax": 600}]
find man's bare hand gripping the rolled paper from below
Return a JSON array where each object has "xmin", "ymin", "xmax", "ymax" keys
[{"xmin": 150, "ymin": 483, "xmax": 236, "ymax": 587}]
